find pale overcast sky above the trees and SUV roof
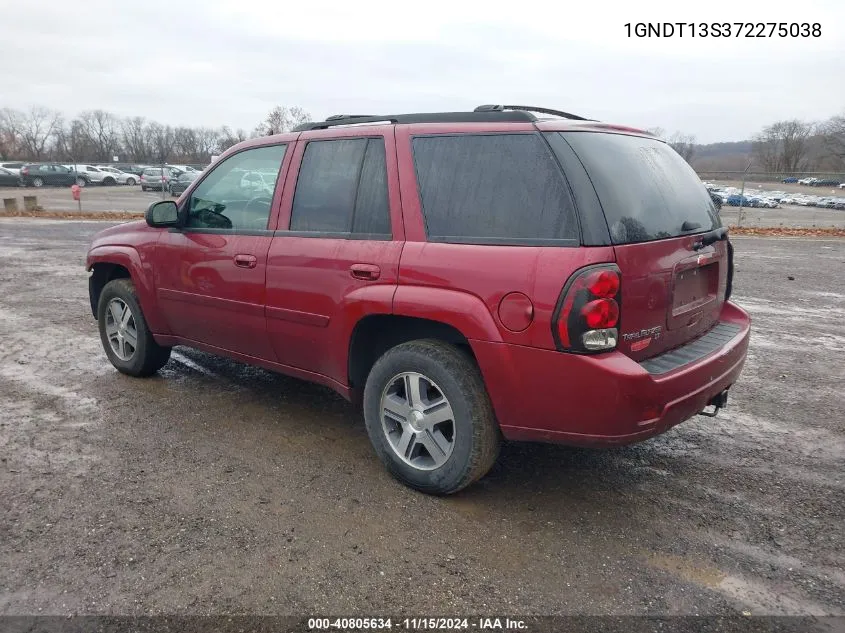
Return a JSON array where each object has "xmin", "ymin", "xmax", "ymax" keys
[{"xmin": 0, "ymin": 0, "xmax": 845, "ymax": 142}]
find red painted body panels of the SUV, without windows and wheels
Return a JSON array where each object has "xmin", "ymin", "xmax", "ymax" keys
[{"xmin": 87, "ymin": 122, "xmax": 749, "ymax": 445}]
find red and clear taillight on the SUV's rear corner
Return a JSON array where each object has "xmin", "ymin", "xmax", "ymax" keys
[{"xmin": 552, "ymin": 264, "xmax": 622, "ymax": 353}]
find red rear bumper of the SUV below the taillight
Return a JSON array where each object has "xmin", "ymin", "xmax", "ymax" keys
[{"xmin": 472, "ymin": 303, "xmax": 750, "ymax": 446}]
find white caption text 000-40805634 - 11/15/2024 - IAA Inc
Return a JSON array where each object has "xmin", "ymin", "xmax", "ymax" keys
[{"xmin": 308, "ymin": 617, "xmax": 528, "ymax": 631}]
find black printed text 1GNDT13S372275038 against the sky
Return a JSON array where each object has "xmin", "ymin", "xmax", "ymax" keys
[{"xmin": 624, "ymin": 22, "xmax": 822, "ymax": 38}]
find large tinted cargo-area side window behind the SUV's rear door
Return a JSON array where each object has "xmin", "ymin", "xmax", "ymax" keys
[{"xmin": 413, "ymin": 134, "xmax": 578, "ymax": 244}]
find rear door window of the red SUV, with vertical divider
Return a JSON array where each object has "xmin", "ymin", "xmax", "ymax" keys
[{"xmin": 290, "ymin": 138, "xmax": 391, "ymax": 239}]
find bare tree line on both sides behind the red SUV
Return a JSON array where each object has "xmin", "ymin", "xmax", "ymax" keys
[{"xmin": 0, "ymin": 106, "xmax": 845, "ymax": 173}]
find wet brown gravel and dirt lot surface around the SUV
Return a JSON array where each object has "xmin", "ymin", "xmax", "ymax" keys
[{"xmin": 0, "ymin": 219, "xmax": 845, "ymax": 615}]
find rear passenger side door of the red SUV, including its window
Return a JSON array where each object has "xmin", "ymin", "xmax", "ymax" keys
[{"xmin": 267, "ymin": 126, "xmax": 404, "ymax": 382}]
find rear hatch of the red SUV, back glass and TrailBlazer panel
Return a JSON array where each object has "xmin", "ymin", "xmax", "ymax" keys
[{"xmin": 547, "ymin": 130, "xmax": 731, "ymax": 361}]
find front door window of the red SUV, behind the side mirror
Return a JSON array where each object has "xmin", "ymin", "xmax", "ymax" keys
[{"xmin": 187, "ymin": 145, "xmax": 287, "ymax": 231}]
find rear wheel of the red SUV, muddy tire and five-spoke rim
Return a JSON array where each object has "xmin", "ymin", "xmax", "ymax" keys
[{"xmin": 364, "ymin": 339, "xmax": 501, "ymax": 495}]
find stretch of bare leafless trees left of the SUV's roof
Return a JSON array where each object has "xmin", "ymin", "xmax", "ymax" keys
[{"xmin": 0, "ymin": 106, "xmax": 311, "ymax": 164}]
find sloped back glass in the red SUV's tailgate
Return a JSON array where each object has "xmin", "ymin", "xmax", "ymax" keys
[{"xmin": 559, "ymin": 132, "xmax": 720, "ymax": 244}]
